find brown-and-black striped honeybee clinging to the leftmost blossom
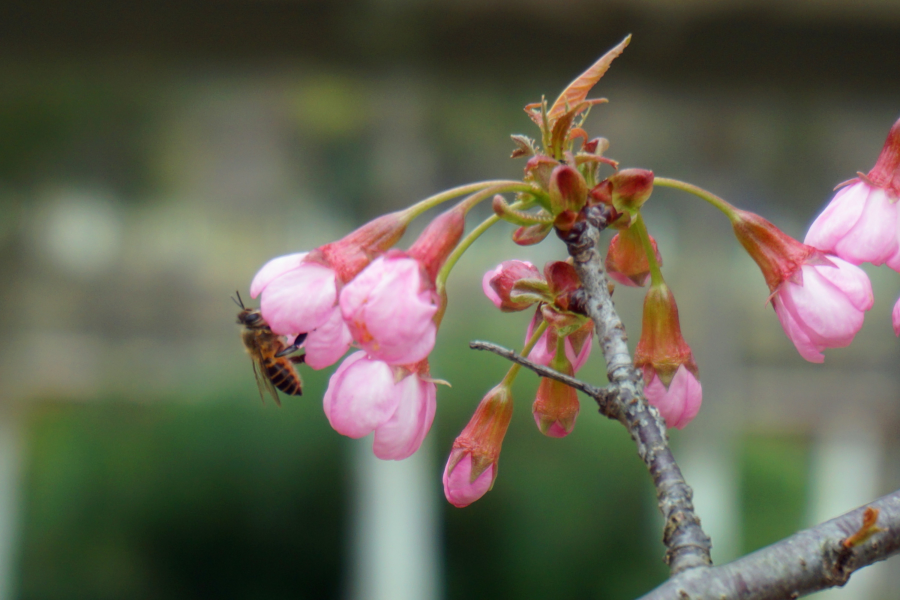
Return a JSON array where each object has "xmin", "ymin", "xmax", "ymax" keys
[{"xmin": 232, "ymin": 292, "xmax": 306, "ymax": 406}]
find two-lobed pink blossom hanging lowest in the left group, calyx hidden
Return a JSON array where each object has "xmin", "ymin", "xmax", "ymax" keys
[{"xmin": 323, "ymin": 352, "xmax": 436, "ymax": 460}]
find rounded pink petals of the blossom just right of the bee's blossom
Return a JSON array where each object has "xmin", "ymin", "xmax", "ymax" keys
[{"xmin": 340, "ymin": 253, "xmax": 438, "ymax": 364}]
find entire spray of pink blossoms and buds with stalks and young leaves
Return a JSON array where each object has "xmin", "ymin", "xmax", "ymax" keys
[{"xmin": 244, "ymin": 38, "xmax": 900, "ymax": 506}]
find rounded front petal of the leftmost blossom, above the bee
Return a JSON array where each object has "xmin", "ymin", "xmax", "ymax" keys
[{"xmin": 259, "ymin": 262, "xmax": 337, "ymax": 335}]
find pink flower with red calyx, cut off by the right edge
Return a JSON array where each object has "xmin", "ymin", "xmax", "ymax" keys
[{"xmin": 804, "ymin": 115, "xmax": 900, "ymax": 271}]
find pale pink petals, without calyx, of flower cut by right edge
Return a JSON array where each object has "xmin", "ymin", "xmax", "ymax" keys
[{"xmin": 804, "ymin": 181, "xmax": 900, "ymax": 268}]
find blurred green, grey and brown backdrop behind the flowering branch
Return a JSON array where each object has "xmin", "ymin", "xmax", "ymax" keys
[{"xmin": 0, "ymin": 0, "xmax": 900, "ymax": 600}]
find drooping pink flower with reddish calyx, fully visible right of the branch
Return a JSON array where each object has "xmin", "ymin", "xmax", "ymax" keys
[{"xmin": 732, "ymin": 210, "xmax": 874, "ymax": 362}]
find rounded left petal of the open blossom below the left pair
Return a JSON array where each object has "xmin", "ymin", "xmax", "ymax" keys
[{"xmin": 323, "ymin": 352, "xmax": 400, "ymax": 438}]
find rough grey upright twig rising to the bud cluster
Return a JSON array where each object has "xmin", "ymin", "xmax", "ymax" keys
[{"xmin": 558, "ymin": 205, "xmax": 712, "ymax": 575}]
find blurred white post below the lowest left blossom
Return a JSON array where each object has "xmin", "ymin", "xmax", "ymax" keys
[{"xmin": 349, "ymin": 437, "xmax": 442, "ymax": 600}]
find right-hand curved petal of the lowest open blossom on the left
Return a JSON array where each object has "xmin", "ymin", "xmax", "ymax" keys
[{"xmin": 372, "ymin": 374, "xmax": 437, "ymax": 460}]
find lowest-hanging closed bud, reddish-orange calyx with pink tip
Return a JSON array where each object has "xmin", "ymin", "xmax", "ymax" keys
[{"xmin": 444, "ymin": 385, "xmax": 512, "ymax": 508}]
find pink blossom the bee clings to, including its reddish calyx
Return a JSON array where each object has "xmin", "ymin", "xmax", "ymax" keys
[{"xmin": 250, "ymin": 211, "xmax": 409, "ymax": 369}]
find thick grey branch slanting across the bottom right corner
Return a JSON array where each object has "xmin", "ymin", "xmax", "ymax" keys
[{"xmin": 641, "ymin": 490, "xmax": 900, "ymax": 600}]
